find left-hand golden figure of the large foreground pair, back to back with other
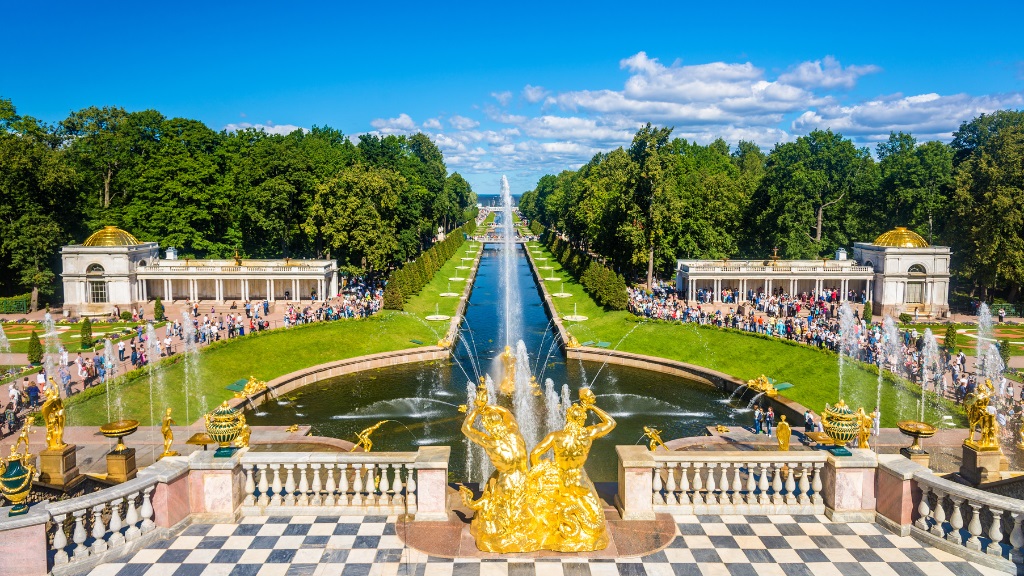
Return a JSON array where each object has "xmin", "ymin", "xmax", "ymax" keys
[{"xmin": 459, "ymin": 384, "xmax": 540, "ymax": 552}]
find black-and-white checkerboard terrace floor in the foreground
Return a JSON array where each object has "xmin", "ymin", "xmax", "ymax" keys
[{"xmin": 90, "ymin": 516, "xmax": 1000, "ymax": 576}]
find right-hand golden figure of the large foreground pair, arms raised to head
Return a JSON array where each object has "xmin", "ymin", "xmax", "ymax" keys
[{"xmin": 529, "ymin": 388, "xmax": 615, "ymax": 552}]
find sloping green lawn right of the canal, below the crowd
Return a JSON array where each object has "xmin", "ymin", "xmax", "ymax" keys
[{"xmin": 530, "ymin": 243, "xmax": 963, "ymax": 426}]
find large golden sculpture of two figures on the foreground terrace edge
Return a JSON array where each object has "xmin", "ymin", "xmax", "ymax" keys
[{"xmin": 461, "ymin": 386, "xmax": 615, "ymax": 552}]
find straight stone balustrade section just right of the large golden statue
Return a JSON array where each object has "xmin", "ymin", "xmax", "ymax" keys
[{"xmin": 617, "ymin": 446, "xmax": 827, "ymax": 518}]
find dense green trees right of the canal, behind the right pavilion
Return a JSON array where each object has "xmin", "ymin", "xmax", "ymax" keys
[{"xmin": 520, "ymin": 111, "xmax": 1024, "ymax": 301}]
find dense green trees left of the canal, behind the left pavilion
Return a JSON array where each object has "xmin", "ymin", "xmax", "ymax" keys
[{"xmin": 0, "ymin": 99, "xmax": 476, "ymax": 305}]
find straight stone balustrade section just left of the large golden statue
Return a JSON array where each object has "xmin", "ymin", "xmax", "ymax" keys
[{"xmin": 241, "ymin": 446, "xmax": 451, "ymax": 520}]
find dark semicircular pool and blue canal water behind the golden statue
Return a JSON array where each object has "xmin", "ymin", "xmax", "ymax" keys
[{"xmin": 246, "ymin": 237, "xmax": 737, "ymax": 482}]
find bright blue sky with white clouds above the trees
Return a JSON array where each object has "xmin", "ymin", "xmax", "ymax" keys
[{"xmin": 0, "ymin": 0, "xmax": 1024, "ymax": 194}]
